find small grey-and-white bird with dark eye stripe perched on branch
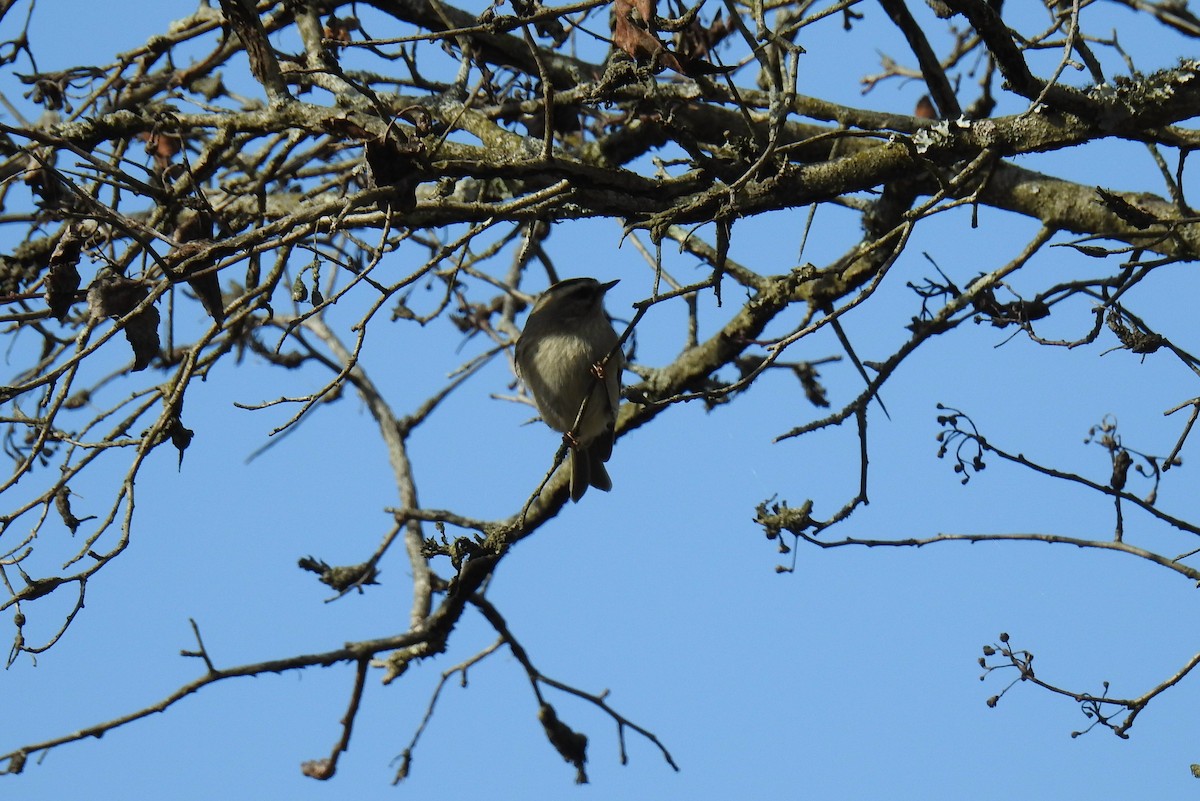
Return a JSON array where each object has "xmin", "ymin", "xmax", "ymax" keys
[{"xmin": 516, "ymin": 278, "xmax": 625, "ymax": 501}]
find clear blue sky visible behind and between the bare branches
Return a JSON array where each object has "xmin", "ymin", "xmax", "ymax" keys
[{"xmin": 0, "ymin": 0, "xmax": 1200, "ymax": 801}]
